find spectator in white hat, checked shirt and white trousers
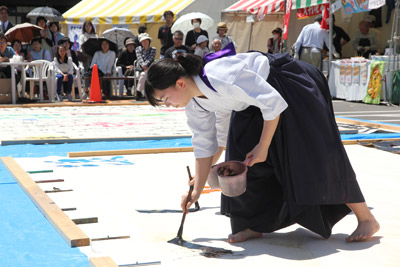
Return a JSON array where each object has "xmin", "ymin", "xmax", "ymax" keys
[{"xmin": 136, "ymin": 33, "xmax": 156, "ymax": 100}]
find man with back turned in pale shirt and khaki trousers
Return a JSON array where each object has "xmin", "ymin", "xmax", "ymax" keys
[{"xmin": 294, "ymin": 15, "xmax": 339, "ymax": 70}]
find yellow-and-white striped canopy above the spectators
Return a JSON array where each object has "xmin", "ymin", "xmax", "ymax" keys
[{"xmin": 63, "ymin": 0, "xmax": 195, "ymax": 24}]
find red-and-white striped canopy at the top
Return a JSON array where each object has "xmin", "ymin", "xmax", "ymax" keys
[{"xmin": 224, "ymin": 0, "xmax": 284, "ymax": 14}]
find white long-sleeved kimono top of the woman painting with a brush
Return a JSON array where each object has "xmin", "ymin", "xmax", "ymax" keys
[{"xmin": 185, "ymin": 52, "xmax": 288, "ymax": 158}]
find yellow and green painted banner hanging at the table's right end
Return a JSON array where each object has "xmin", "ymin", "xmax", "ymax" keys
[{"xmin": 363, "ymin": 61, "xmax": 385, "ymax": 104}]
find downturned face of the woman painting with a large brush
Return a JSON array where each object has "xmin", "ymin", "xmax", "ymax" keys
[{"xmin": 154, "ymin": 79, "xmax": 192, "ymax": 108}]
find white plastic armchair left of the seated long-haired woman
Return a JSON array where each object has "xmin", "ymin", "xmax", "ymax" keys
[{"xmin": 21, "ymin": 60, "xmax": 55, "ymax": 102}]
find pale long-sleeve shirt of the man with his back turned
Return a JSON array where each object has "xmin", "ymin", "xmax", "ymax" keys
[{"xmin": 294, "ymin": 22, "xmax": 334, "ymax": 53}]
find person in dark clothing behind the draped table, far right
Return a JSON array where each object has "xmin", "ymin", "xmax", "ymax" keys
[{"xmin": 353, "ymin": 21, "xmax": 378, "ymax": 58}]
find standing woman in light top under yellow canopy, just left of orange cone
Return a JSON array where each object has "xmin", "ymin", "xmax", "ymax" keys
[{"xmin": 79, "ymin": 20, "xmax": 97, "ymax": 99}]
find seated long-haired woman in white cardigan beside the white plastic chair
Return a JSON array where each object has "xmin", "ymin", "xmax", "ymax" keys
[{"xmin": 54, "ymin": 45, "xmax": 74, "ymax": 101}]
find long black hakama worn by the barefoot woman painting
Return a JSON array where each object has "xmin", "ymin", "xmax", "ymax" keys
[{"xmin": 221, "ymin": 54, "xmax": 364, "ymax": 238}]
